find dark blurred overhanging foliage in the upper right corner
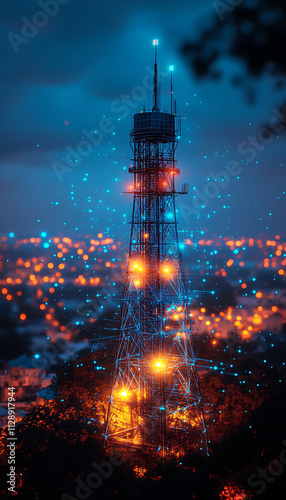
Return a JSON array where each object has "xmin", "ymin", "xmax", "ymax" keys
[{"xmin": 182, "ymin": 0, "xmax": 286, "ymax": 101}]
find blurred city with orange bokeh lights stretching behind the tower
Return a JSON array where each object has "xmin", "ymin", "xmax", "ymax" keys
[{"xmin": 0, "ymin": 233, "xmax": 286, "ymax": 352}]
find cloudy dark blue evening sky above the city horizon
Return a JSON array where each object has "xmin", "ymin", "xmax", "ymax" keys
[{"xmin": 0, "ymin": 0, "xmax": 286, "ymax": 238}]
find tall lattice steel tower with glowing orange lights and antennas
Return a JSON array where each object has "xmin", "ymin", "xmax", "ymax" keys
[{"xmin": 105, "ymin": 40, "xmax": 207, "ymax": 456}]
